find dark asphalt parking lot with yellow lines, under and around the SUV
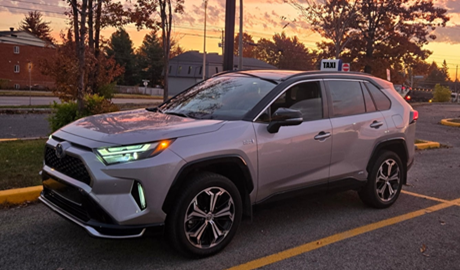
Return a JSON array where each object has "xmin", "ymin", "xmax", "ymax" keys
[{"xmin": 0, "ymin": 104, "xmax": 460, "ymax": 269}]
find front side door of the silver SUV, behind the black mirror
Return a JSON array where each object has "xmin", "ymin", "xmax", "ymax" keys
[{"xmin": 254, "ymin": 80, "xmax": 332, "ymax": 201}]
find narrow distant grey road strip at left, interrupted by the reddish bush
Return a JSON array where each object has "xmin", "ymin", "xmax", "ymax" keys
[{"xmin": 0, "ymin": 96, "xmax": 158, "ymax": 106}]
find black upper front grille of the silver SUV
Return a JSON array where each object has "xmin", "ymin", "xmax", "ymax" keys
[{"xmin": 45, "ymin": 145, "xmax": 91, "ymax": 185}]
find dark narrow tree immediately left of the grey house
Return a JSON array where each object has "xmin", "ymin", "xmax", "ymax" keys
[{"xmin": 137, "ymin": 31, "xmax": 164, "ymax": 85}]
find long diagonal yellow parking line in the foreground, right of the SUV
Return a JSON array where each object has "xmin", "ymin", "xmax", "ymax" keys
[{"xmin": 229, "ymin": 196, "xmax": 460, "ymax": 270}]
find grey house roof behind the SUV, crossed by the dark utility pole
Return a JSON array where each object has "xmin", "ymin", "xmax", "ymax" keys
[{"xmin": 170, "ymin": 51, "xmax": 276, "ymax": 69}]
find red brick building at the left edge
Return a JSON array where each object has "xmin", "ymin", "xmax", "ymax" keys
[{"xmin": 0, "ymin": 28, "xmax": 56, "ymax": 89}]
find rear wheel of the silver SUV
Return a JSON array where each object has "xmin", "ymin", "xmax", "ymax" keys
[{"xmin": 358, "ymin": 151, "xmax": 406, "ymax": 208}]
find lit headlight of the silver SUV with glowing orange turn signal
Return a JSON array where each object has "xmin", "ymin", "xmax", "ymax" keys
[{"xmin": 96, "ymin": 140, "xmax": 172, "ymax": 164}]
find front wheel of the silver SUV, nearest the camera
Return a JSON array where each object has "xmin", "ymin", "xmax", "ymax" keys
[{"xmin": 166, "ymin": 172, "xmax": 243, "ymax": 257}]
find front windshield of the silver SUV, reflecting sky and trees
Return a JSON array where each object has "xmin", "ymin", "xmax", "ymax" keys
[{"xmin": 158, "ymin": 74, "xmax": 276, "ymax": 120}]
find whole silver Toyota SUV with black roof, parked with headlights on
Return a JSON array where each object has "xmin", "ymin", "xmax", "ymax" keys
[{"xmin": 40, "ymin": 70, "xmax": 418, "ymax": 256}]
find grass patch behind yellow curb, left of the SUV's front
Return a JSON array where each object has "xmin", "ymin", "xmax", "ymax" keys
[{"xmin": 0, "ymin": 139, "xmax": 46, "ymax": 190}]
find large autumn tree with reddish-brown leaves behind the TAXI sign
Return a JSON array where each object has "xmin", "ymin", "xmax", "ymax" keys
[{"xmin": 292, "ymin": 0, "xmax": 449, "ymax": 77}]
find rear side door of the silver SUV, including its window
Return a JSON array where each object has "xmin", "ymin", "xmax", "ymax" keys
[{"xmin": 325, "ymin": 79, "xmax": 388, "ymax": 186}]
